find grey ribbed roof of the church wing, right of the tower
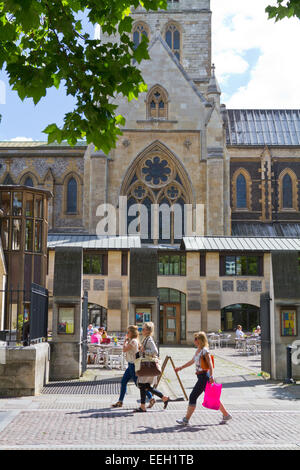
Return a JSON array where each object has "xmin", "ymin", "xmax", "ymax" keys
[{"xmin": 226, "ymin": 109, "xmax": 300, "ymax": 146}]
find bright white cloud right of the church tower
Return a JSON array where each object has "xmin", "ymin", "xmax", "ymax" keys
[{"xmin": 211, "ymin": 0, "xmax": 300, "ymax": 108}]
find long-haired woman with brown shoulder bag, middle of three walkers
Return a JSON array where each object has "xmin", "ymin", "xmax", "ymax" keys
[{"xmin": 134, "ymin": 322, "xmax": 170, "ymax": 413}]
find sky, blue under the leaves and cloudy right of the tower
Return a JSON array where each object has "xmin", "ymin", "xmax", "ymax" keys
[{"xmin": 0, "ymin": 0, "xmax": 300, "ymax": 141}]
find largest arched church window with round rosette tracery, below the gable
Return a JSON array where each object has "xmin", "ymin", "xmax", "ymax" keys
[{"xmin": 121, "ymin": 148, "xmax": 191, "ymax": 243}]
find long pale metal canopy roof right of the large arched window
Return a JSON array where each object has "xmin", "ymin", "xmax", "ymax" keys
[{"xmin": 182, "ymin": 237, "xmax": 300, "ymax": 251}]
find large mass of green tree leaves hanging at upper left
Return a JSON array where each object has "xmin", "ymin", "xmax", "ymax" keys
[{"xmin": 0, "ymin": 0, "xmax": 167, "ymax": 153}]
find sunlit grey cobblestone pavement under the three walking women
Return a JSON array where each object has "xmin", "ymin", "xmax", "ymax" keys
[{"xmin": 0, "ymin": 348, "xmax": 300, "ymax": 450}]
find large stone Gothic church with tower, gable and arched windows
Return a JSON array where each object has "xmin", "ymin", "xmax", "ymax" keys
[{"xmin": 0, "ymin": 0, "xmax": 300, "ymax": 344}]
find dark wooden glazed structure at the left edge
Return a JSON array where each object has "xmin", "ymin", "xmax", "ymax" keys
[{"xmin": 0, "ymin": 185, "xmax": 53, "ymax": 328}]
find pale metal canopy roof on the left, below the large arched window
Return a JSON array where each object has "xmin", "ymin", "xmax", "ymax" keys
[{"xmin": 48, "ymin": 233, "xmax": 141, "ymax": 250}]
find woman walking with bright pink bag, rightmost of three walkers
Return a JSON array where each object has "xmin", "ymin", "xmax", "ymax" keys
[{"xmin": 175, "ymin": 331, "xmax": 232, "ymax": 426}]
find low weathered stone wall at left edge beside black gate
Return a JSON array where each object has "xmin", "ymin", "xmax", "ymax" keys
[{"xmin": 0, "ymin": 342, "xmax": 50, "ymax": 397}]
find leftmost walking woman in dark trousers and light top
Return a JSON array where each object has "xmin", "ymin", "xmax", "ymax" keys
[{"xmin": 112, "ymin": 325, "xmax": 155, "ymax": 408}]
